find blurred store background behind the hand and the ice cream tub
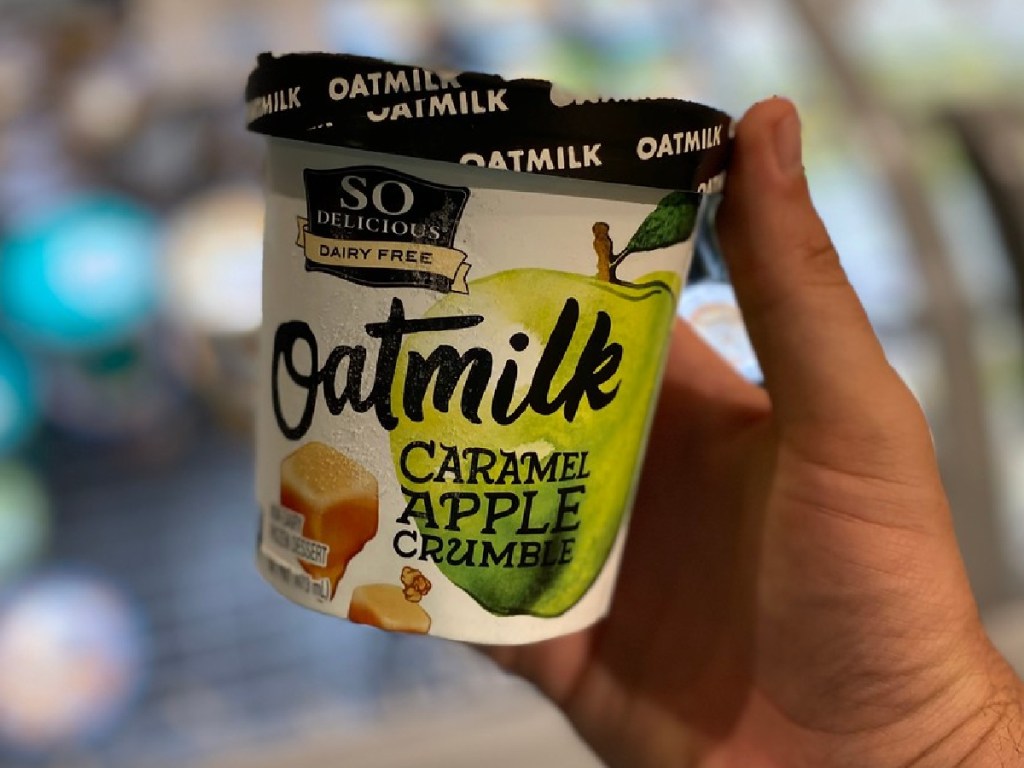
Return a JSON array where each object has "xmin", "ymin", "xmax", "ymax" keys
[{"xmin": 0, "ymin": 0, "xmax": 1024, "ymax": 768}]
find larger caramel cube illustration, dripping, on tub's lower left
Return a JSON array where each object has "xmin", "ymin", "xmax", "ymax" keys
[{"xmin": 281, "ymin": 442, "xmax": 379, "ymax": 595}]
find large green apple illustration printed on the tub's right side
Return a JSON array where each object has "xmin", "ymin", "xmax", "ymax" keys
[{"xmin": 391, "ymin": 192, "xmax": 700, "ymax": 616}]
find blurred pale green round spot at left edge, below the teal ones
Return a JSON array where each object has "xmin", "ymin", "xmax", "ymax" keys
[{"xmin": 0, "ymin": 462, "xmax": 50, "ymax": 586}]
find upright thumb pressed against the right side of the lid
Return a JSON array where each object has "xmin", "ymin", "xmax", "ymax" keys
[{"xmin": 717, "ymin": 98, "xmax": 909, "ymax": 438}]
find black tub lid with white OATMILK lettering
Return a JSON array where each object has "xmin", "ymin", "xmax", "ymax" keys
[{"xmin": 246, "ymin": 53, "xmax": 731, "ymax": 191}]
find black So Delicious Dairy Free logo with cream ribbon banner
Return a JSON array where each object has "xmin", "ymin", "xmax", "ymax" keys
[{"xmin": 296, "ymin": 166, "xmax": 470, "ymax": 294}]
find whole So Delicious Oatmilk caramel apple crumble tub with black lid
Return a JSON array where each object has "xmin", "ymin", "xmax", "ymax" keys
[{"xmin": 246, "ymin": 54, "xmax": 730, "ymax": 643}]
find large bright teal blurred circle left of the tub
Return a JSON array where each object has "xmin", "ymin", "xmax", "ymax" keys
[{"xmin": 0, "ymin": 195, "xmax": 157, "ymax": 351}]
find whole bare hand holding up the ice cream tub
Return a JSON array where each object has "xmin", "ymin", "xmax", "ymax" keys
[{"xmin": 490, "ymin": 99, "xmax": 1024, "ymax": 768}]
